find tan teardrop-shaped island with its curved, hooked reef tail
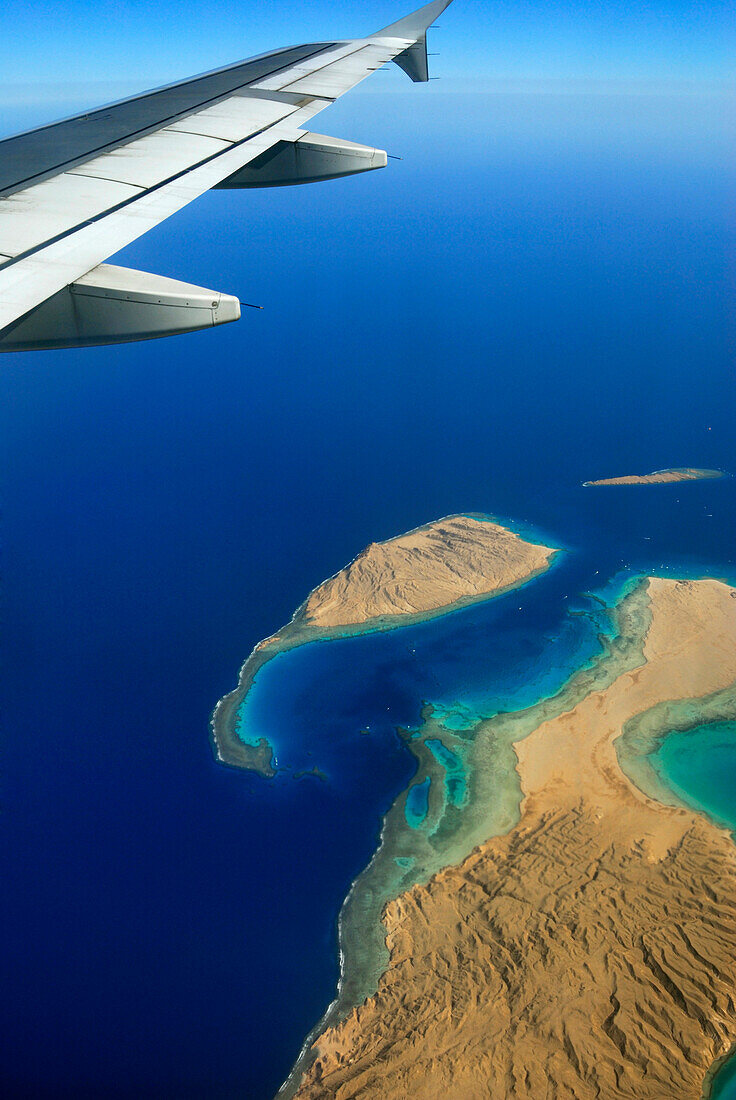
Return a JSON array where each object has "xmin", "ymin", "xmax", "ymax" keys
[{"xmin": 211, "ymin": 515, "xmax": 557, "ymax": 778}]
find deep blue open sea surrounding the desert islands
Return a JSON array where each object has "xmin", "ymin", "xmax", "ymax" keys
[{"xmin": 0, "ymin": 86, "xmax": 736, "ymax": 1100}]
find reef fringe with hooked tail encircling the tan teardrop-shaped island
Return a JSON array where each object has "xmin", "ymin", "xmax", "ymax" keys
[{"xmin": 209, "ymin": 513, "xmax": 558, "ymax": 779}]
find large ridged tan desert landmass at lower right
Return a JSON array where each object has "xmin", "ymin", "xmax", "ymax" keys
[{"xmin": 286, "ymin": 579, "xmax": 736, "ymax": 1100}]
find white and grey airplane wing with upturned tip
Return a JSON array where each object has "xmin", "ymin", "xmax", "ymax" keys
[{"xmin": 0, "ymin": 0, "xmax": 451, "ymax": 351}]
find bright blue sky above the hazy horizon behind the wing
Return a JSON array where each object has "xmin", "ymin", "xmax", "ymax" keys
[{"xmin": 0, "ymin": 0, "xmax": 736, "ymax": 132}]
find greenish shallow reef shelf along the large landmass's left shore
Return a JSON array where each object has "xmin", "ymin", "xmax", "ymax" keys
[{"xmin": 278, "ymin": 576, "xmax": 650, "ymax": 1100}]
